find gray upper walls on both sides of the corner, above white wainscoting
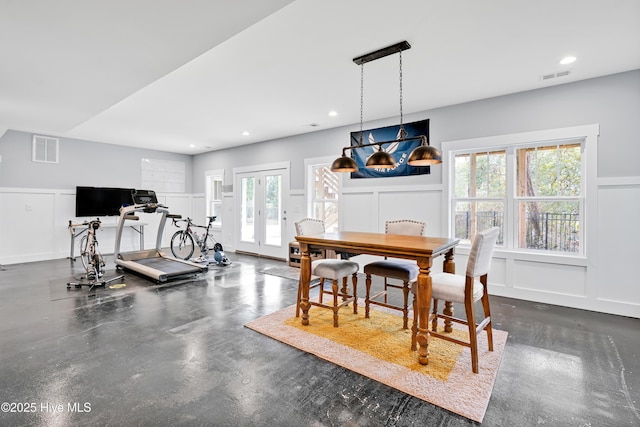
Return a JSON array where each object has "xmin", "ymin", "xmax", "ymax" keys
[{"xmin": 0, "ymin": 70, "xmax": 640, "ymax": 193}]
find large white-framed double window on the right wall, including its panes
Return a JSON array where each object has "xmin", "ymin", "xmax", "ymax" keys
[{"xmin": 443, "ymin": 126, "xmax": 597, "ymax": 255}]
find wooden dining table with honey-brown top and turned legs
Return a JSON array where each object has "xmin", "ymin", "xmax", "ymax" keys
[{"xmin": 296, "ymin": 231, "xmax": 459, "ymax": 365}]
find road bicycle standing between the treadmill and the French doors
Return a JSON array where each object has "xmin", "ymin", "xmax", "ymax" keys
[{"xmin": 171, "ymin": 216, "xmax": 231, "ymax": 266}]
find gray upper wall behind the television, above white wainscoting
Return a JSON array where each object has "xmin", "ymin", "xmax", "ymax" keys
[{"xmin": 0, "ymin": 130, "xmax": 193, "ymax": 193}]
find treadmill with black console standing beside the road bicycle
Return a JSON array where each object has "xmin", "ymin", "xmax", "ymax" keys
[{"xmin": 114, "ymin": 190, "xmax": 207, "ymax": 282}]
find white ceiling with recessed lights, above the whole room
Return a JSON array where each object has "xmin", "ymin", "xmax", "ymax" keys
[{"xmin": 0, "ymin": 0, "xmax": 640, "ymax": 154}]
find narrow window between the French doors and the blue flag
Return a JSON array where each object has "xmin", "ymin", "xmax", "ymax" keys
[{"xmin": 307, "ymin": 161, "xmax": 340, "ymax": 232}]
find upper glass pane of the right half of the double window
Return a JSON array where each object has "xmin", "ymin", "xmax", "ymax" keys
[{"xmin": 516, "ymin": 144, "xmax": 582, "ymax": 197}]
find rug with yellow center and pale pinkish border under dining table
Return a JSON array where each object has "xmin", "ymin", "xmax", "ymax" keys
[{"xmin": 245, "ymin": 304, "xmax": 507, "ymax": 422}]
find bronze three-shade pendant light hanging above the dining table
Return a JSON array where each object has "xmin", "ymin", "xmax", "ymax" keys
[{"xmin": 331, "ymin": 41, "xmax": 442, "ymax": 172}]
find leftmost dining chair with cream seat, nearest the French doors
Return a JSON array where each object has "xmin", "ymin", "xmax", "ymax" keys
[{"xmin": 295, "ymin": 218, "xmax": 360, "ymax": 327}]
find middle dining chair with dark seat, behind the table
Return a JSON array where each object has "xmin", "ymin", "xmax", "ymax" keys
[{"xmin": 364, "ymin": 219, "xmax": 425, "ymax": 329}]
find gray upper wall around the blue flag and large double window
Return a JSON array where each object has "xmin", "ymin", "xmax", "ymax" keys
[{"xmin": 193, "ymin": 70, "xmax": 640, "ymax": 193}]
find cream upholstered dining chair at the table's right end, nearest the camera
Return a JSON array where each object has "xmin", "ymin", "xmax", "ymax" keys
[{"xmin": 411, "ymin": 227, "xmax": 500, "ymax": 374}]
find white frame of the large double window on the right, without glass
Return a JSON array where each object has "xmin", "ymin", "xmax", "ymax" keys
[{"xmin": 442, "ymin": 124, "xmax": 599, "ymax": 265}]
